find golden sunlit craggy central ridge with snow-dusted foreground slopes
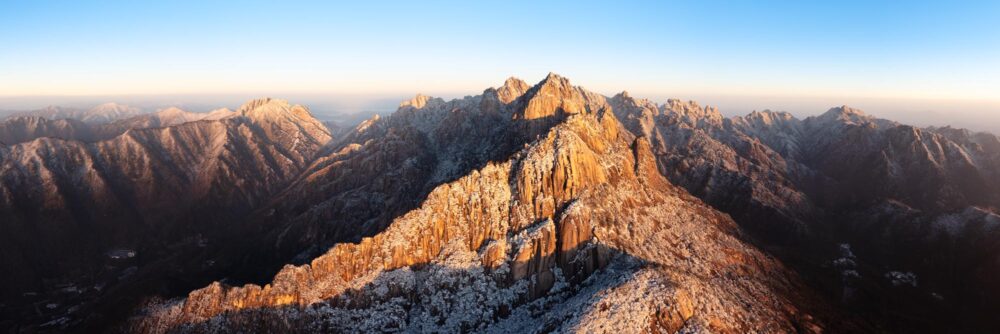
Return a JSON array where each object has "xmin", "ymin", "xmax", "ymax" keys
[{"xmin": 124, "ymin": 75, "xmax": 844, "ymax": 332}]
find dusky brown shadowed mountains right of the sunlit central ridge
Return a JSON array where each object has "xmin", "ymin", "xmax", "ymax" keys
[{"xmin": 612, "ymin": 94, "xmax": 1000, "ymax": 330}]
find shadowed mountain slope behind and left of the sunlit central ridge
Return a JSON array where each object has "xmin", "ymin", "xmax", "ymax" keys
[{"xmin": 219, "ymin": 76, "xmax": 612, "ymax": 280}]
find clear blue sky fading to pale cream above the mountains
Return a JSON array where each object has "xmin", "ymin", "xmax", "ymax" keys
[{"xmin": 0, "ymin": 0, "xmax": 1000, "ymax": 129}]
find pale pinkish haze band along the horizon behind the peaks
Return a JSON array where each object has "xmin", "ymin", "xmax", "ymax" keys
[{"xmin": 0, "ymin": 85, "xmax": 1000, "ymax": 134}]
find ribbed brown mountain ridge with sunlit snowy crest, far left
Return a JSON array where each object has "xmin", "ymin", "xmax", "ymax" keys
[{"xmin": 0, "ymin": 100, "xmax": 330, "ymax": 330}]
